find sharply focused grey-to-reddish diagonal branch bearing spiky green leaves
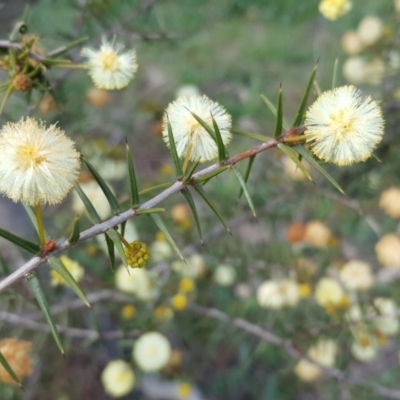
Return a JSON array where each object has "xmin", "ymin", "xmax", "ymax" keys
[{"xmin": 0, "ymin": 134, "xmax": 285, "ymax": 293}]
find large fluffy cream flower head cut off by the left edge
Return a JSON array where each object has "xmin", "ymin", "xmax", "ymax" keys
[{"xmin": 0, "ymin": 118, "xmax": 80, "ymax": 206}]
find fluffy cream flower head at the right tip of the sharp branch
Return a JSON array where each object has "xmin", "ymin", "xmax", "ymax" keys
[{"xmin": 305, "ymin": 86, "xmax": 384, "ymax": 166}]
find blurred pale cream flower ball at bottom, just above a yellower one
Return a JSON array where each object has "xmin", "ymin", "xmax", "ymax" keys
[{"xmin": 133, "ymin": 332, "xmax": 171, "ymax": 372}]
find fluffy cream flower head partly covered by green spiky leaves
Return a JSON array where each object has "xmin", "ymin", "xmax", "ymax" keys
[{"xmin": 163, "ymin": 96, "xmax": 232, "ymax": 162}]
